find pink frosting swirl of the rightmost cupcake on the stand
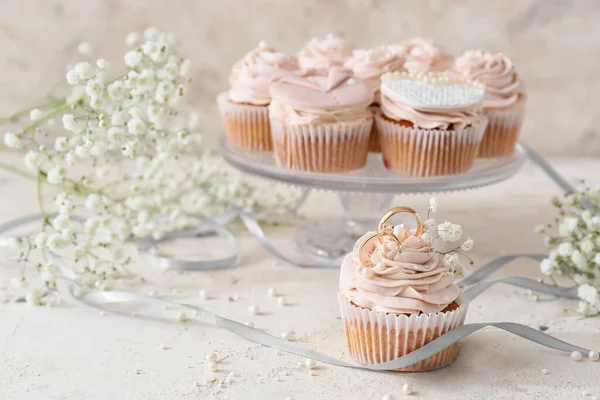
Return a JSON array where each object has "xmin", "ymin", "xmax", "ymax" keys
[{"xmin": 454, "ymin": 50, "xmax": 526, "ymax": 108}]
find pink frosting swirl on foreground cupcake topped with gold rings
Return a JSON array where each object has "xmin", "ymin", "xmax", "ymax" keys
[{"xmin": 340, "ymin": 227, "xmax": 460, "ymax": 314}]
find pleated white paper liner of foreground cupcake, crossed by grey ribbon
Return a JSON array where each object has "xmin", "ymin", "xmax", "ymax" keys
[{"xmin": 338, "ymin": 292, "xmax": 468, "ymax": 372}]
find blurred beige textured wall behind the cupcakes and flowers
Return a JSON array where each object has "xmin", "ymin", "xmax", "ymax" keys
[{"xmin": 0, "ymin": 0, "xmax": 600, "ymax": 155}]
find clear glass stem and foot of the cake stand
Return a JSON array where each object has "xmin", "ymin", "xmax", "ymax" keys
[{"xmin": 294, "ymin": 193, "xmax": 394, "ymax": 261}]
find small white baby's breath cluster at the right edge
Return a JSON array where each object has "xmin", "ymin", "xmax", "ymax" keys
[{"xmin": 535, "ymin": 182, "xmax": 600, "ymax": 317}]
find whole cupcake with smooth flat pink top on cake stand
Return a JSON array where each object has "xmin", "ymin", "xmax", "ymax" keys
[{"xmin": 269, "ymin": 67, "xmax": 373, "ymax": 172}]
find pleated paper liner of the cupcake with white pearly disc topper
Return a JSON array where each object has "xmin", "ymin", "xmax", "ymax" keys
[{"xmin": 375, "ymin": 113, "xmax": 487, "ymax": 176}]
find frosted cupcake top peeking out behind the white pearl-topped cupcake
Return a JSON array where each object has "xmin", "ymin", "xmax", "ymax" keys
[{"xmin": 390, "ymin": 37, "xmax": 454, "ymax": 73}]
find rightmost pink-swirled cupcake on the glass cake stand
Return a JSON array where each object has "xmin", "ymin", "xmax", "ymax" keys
[{"xmin": 454, "ymin": 50, "xmax": 527, "ymax": 157}]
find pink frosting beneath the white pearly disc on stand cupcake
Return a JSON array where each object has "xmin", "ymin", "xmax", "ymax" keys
[{"xmin": 381, "ymin": 86, "xmax": 483, "ymax": 130}]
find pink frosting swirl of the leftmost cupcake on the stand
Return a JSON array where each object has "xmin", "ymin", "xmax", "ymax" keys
[{"xmin": 229, "ymin": 42, "xmax": 298, "ymax": 105}]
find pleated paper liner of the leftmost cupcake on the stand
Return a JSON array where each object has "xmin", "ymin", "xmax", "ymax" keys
[{"xmin": 217, "ymin": 92, "xmax": 273, "ymax": 151}]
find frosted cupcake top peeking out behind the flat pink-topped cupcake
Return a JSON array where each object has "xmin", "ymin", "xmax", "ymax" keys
[{"xmin": 297, "ymin": 33, "xmax": 354, "ymax": 75}]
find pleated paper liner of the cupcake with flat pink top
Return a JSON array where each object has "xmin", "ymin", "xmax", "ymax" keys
[{"xmin": 271, "ymin": 118, "xmax": 373, "ymax": 172}]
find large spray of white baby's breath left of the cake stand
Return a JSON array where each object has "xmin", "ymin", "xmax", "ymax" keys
[{"xmin": 0, "ymin": 28, "xmax": 297, "ymax": 304}]
